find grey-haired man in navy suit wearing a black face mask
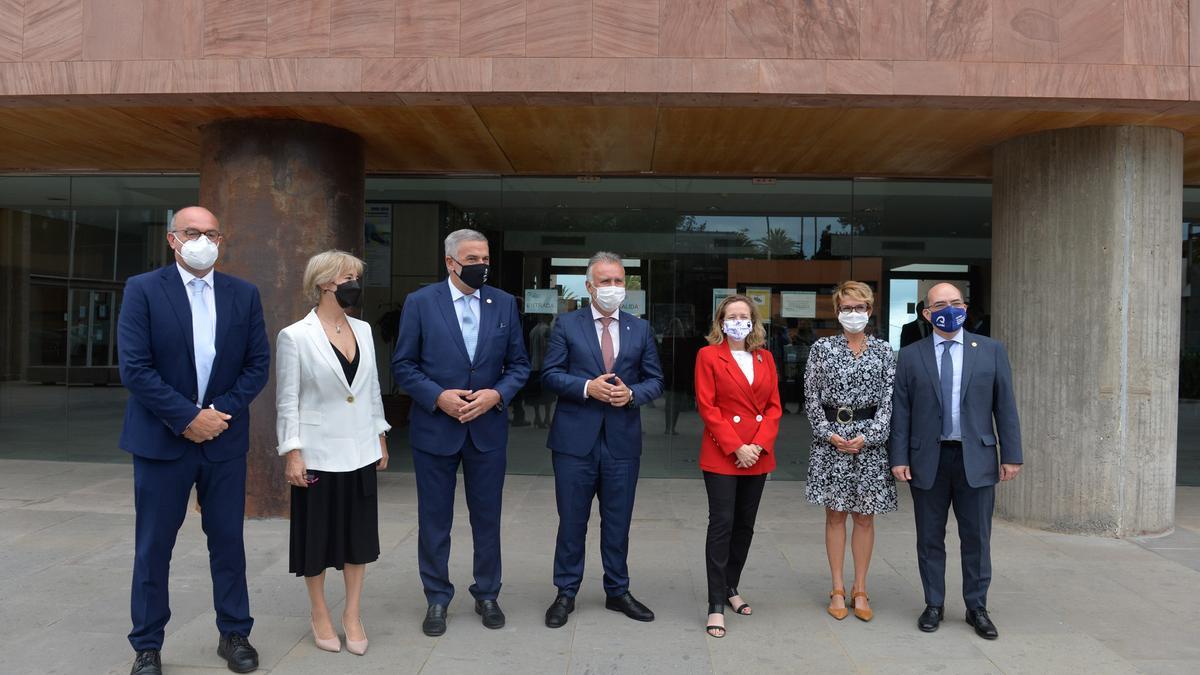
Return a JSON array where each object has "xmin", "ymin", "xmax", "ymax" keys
[{"xmin": 391, "ymin": 229, "xmax": 529, "ymax": 635}]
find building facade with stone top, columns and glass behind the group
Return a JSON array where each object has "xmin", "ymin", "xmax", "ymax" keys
[{"xmin": 0, "ymin": 0, "xmax": 1200, "ymax": 536}]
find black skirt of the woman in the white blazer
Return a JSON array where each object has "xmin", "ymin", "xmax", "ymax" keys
[{"xmin": 288, "ymin": 462, "xmax": 379, "ymax": 577}]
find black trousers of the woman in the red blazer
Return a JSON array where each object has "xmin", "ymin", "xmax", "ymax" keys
[{"xmin": 704, "ymin": 471, "xmax": 767, "ymax": 605}]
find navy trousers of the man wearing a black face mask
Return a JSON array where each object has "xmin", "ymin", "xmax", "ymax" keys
[{"xmin": 413, "ymin": 436, "xmax": 508, "ymax": 605}]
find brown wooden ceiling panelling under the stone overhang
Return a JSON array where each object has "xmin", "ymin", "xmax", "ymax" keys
[{"xmin": 0, "ymin": 98, "xmax": 1200, "ymax": 185}]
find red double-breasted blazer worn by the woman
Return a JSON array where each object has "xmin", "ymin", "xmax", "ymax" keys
[{"xmin": 696, "ymin": 342, "xmax": 782, "ymax": 476}]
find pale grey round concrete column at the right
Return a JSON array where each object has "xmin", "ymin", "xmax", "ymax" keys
[{"xmin": 992, "ymin": 126, "xmax": 1183, "ymax": 537}]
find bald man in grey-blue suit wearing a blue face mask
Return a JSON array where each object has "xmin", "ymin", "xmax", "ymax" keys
[{"xmin": 889, "ymin": 283, "xmax": 1022, "ymax": 640}]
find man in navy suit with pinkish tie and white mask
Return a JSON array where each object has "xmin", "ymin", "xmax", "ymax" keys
[{"xmin": 541, "ymin": 251, "xmax": 662, "ymax": 628}]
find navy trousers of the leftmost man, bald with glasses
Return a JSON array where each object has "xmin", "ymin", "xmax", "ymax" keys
[{"xmin": 130, "ymin": 447, "xmax": 254, "ymax": 651}]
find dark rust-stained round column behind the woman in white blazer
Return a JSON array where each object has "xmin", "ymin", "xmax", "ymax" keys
[{"xmin": 200, "ymin": 119, "xmax": 365, "ymax": 518}]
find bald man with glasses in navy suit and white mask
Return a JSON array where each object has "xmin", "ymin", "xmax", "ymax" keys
[{"xmin": 118, "ymin": 207, "xmax": 271, "ymax": 675}]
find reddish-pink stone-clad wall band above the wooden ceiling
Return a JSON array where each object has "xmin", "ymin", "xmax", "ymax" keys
[{"xmin": 0, "ymin": 0, "xmax": 1200, "ymax": 102}]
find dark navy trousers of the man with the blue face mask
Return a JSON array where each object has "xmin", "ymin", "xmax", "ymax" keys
[{"xmin": 912, "ymin": 443, "xmax": 996, "ymax": 609}]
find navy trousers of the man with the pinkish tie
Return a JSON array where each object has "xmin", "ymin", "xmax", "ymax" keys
[{"xmin": 553, "ymin": 430, "xmax": 642, "ymax": 597}]
